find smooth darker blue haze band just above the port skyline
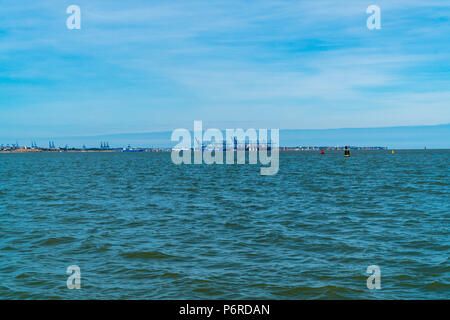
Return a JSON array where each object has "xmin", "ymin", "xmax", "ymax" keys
[{"xmin": 0, "ymin": 124, "xmax": 450, "ymax": 149}]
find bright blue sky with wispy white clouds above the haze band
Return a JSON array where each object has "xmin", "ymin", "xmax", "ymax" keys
[{"xmin": 0, "ymin": 0, "xmax": 450, "ymax": 139}]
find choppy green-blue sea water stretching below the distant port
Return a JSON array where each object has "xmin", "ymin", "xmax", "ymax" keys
[{"xmin": 0, "ymin": 150, "xmax": 450, "ymax": 299}]
